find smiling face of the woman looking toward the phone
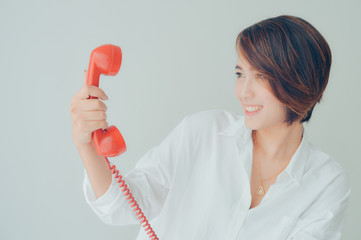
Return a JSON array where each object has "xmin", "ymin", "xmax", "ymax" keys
[{"xmin": 235, "ymin": 55, "xmax": 286, "ymax": 130}]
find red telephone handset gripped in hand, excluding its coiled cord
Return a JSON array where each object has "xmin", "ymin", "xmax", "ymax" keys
[{"xmin": 87, "ymin": 44, "xmax": 127, "ymax": 157}]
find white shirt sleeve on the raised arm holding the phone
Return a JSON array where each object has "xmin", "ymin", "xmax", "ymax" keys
[{"xmin": 83, "ymin": 118, "xmax": 186, "ymax": 225}]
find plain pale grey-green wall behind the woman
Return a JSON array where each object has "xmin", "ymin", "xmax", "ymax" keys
[{"xmin": 0, "ymin": 0, "xmax": 361, "ymax": 240}]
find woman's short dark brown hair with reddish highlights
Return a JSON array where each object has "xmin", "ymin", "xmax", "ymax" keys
[{"xmin": 236, "ymin": 15, "xmax": 332, "ymax": 125}]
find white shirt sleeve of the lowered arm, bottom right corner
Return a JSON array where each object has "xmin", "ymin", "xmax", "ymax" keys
[{"xmin": 288, "ymin": 171, "xmax": 351, "ymax": 240}]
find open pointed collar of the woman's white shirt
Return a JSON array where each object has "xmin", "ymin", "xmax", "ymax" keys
[{"xmin": 218, "ymin": 114, "xmax": 310, "ymax": 184}]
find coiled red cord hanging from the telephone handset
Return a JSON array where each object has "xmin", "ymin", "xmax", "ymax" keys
[{"xmin": 104, "ymin": 157, "xmax": 159, "ymax": 240}]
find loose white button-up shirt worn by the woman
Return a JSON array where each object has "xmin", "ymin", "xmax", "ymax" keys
[{"xmin": 83, "ymin": 110, "xmax": 351, "ymax": 240}]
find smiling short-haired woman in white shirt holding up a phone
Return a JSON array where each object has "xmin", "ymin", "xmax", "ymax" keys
[{"xmin": 71, "ymin": 15, "xmax": 351, "ymax": 240}]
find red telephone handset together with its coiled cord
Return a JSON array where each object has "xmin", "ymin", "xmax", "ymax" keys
[{"xmin": 87, "ymin": 44, "xmax": 158, "ymax": 240}]
